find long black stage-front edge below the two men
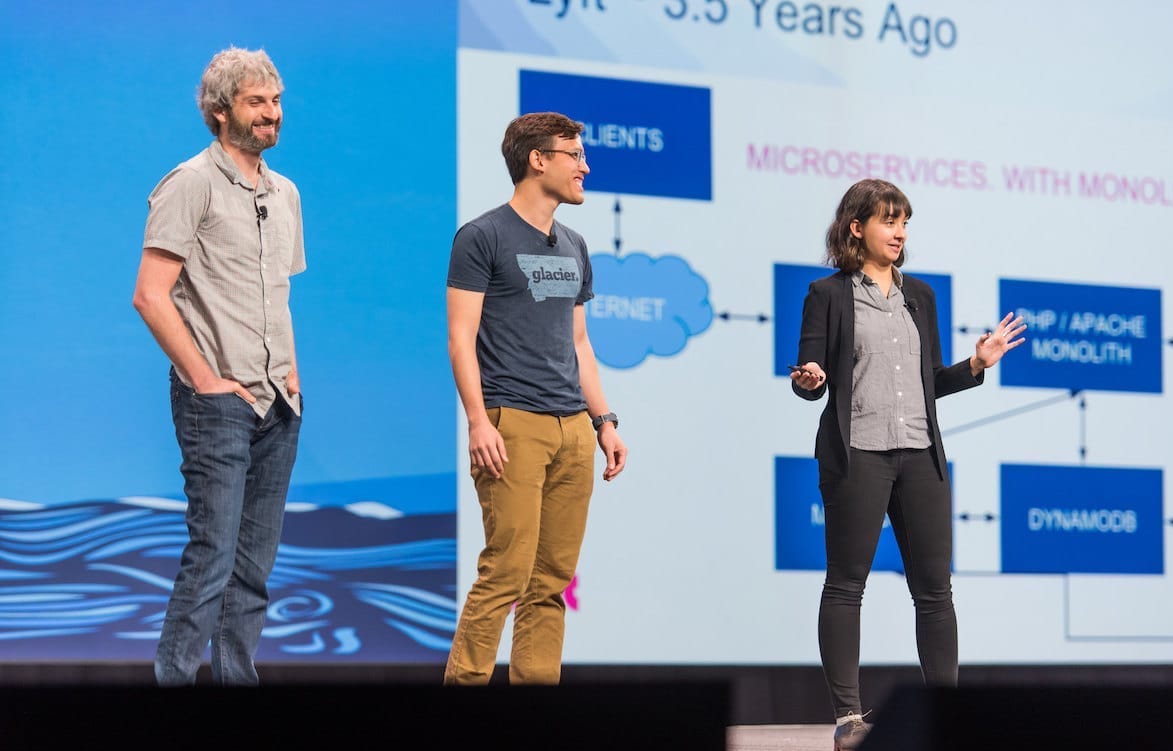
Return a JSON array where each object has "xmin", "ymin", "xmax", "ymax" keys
[{"xmin": 0, "ymin": 683, "xmax": 728, "ymax": 751}]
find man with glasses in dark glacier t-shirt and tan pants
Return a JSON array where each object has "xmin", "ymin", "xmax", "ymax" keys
[{"xmin": 443, "ymin": 113, "xmax": 628, "ymax": 684}]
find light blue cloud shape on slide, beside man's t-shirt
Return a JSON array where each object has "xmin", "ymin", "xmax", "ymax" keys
[{"xmin": 587, "ymin": 252, "xmax": 713, "ymax": 368}]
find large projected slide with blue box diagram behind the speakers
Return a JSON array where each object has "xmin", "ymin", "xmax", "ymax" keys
[{"xmin": 457, "ymin": 0, "xmax": 1173, "ymax": 664}]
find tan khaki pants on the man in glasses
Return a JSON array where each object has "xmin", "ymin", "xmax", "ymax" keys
[{"xmin": 443, "ymin": 407, "xmax": 596, "ymax": 684}]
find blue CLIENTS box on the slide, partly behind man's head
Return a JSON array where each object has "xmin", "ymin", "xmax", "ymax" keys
[{"xmin": 518, "ymin": 70, "xmax": 713, "ymax": 201}]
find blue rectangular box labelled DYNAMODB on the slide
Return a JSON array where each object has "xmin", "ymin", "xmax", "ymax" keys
[{"xmin": 1002, "ymin": 465, "xmax": 1165, "ymax": 574}]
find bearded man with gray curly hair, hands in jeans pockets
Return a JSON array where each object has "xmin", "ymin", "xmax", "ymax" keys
[{"xmin": 134, "ymin": 47, "xmax": 305, "ymax": 685}]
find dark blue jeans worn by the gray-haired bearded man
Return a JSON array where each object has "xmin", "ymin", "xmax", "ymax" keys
[{"xmin": 155, "ymin": 371, "xmax": 301, "ymax": 685}]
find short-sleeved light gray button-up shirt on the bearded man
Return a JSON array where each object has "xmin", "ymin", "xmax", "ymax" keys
[{"xmin": 143, "ymin": 141, "xmax": 305, "ymax": 417}]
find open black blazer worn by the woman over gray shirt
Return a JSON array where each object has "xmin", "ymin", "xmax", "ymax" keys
[{"xmin": 791, "ymin": 271, "xmax": 985, "ymax": 480}]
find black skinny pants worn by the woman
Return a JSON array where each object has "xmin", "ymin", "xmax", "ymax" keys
[{"xmin": 819, "ymin": 448, "xmax": 957, "ymax": 718}]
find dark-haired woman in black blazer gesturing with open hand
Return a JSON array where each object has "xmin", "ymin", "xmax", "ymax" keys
[{"xmin": 791, "ymin": 180, "xmax": 1026, "ymax": 751}]
